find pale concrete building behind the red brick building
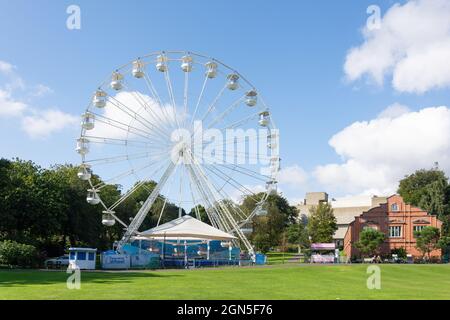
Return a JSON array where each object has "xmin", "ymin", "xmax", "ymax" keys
[{"xmin": 297, "ymin": 192, "xmax": 387, "ymax": 248}]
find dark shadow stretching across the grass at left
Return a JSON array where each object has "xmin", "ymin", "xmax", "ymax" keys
[{"xmin": 0, "ymin": 270, "xmax": 183, "ymax": 289}]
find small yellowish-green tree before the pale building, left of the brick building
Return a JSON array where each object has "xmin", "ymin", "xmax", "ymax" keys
[{"xmin": 308, "ymin": 202, "xmax": 338, "ymax": 243}]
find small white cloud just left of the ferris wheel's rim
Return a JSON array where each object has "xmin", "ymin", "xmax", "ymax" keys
[{"xmin": 22, "ymin": 110, "xmax": 80, "ymax": 139}]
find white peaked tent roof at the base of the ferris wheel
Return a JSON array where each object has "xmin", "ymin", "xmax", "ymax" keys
[{"xmin": 139, "ymin": 215, "xmax": 236, "ymax": 241}]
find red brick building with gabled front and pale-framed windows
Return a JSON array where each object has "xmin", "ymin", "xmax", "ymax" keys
[{"xmin": 344, "ymin": 195, "xmax": 442, "ymax": 258}]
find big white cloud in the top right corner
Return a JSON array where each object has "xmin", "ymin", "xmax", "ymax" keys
[{"xmin": 344, "ymin": 0, "xmax": 450, "ymax": 93}]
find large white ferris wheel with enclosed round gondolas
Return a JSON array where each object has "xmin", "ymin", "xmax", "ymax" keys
[{"xmin": 76, "ymin": 51, "xmax": 280, "ymax": 256}]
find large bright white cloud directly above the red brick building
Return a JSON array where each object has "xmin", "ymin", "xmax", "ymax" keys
[{"xmin": 314, "ymin": 107, "xmax": 450, "ymax": 195}]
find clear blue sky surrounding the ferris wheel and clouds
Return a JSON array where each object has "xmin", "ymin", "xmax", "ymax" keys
[{"xmin": 0, "ymin": 0, "xmax": 450, "ymax": 204}]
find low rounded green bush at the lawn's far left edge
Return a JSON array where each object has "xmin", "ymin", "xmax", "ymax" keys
[{"xmin": 0, "ymin": 240, "xmax": 38, "ymax": 267}]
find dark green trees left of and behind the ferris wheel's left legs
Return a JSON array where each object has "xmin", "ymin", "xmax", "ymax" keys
[{"xmin": 0, "ymin": 159, "xmax": 184, "ymax": 260}]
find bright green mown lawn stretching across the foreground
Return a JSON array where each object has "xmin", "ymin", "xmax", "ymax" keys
[{"xmin": 0, "ymin": 265, "xmax": 450, "ymax": 299}]
